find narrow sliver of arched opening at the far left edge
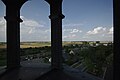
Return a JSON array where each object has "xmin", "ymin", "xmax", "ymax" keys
[{"xmin": 0, "ymin": 1, "xmax": 7, "ymax": 70}]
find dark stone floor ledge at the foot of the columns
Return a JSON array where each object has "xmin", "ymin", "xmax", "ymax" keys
[{"xmin": 0, "ymin": 60, "xmax": 102, "ymax": 80}]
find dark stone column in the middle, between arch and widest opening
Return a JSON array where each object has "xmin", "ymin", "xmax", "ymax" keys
[{"xmin": 45, "ymin": 0, "xmax": 64, "ymax": 70}]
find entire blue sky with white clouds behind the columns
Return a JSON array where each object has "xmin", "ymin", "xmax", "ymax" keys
[{"xmin": 0, "ymin": 0, "xmax": 113, "ymax": 42}]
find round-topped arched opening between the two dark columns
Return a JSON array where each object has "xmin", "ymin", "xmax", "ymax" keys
[{"xmin": 20, "ymin": 0, "xmax": 51, "ymax": 67}]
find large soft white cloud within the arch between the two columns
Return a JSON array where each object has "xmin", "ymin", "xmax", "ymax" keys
[{"xmin": 20, "ymin": 16, "xmax": 45, "ymax": 36}]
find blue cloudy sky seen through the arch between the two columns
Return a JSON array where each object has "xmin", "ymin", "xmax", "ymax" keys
[{"xmin": 20, "ymin": 0, "xmax": 50, "ymax": 42}]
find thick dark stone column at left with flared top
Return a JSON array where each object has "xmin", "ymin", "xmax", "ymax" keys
[{"xmin": 2, "ymin": 0, "xmax": 27, "ymax": 69}]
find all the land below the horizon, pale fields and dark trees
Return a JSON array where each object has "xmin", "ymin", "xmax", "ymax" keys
[{"xmin": 0, "ymin": 41, "xmax": 113, "ymax": 77}]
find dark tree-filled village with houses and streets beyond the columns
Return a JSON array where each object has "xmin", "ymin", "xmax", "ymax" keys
[{"xmin": 18, "ymin": 41, "xmax": 113, "ymax": 77}]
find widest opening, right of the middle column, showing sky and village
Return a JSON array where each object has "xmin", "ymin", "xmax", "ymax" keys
[{"xmin": 63, "ymin": 0, "xmax": 113, "ymax": 77}]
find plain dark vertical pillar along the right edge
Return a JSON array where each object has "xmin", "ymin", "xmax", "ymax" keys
[{"xmin": 113, "ymin": 0, "xmax": 120, "ymax": 80}]
